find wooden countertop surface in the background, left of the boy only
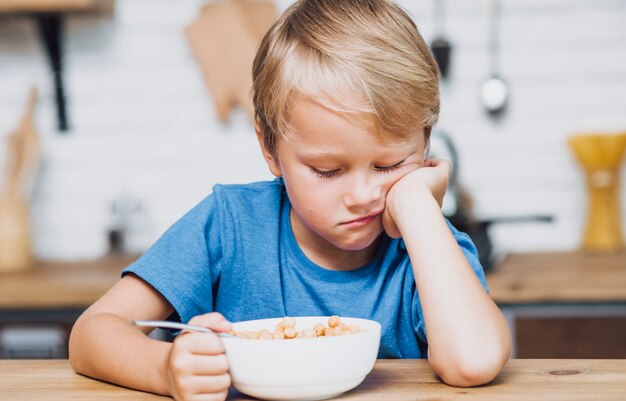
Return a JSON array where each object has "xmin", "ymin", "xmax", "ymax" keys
[{"xmin": 0, "ymin": 256, "xmax": 137, "ymax": 309}]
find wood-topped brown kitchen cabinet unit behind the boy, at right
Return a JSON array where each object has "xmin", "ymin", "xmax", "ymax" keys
[{"xmin": 487, "ymin": 251, "xmax": 626, "ymax": 358}]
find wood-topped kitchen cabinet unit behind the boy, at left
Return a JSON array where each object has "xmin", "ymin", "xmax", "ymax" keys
[{"xmin": 0, "ymin": 256, "xmax": 137, "ymax": 358}]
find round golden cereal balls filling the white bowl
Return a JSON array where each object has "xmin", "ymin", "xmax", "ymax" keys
[{"xmin": 231, "ymin": 316, "xmax": 361, "ymax": 340}]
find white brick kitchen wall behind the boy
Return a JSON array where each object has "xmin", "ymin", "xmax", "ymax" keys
[{"xmin": 0, "ymin": 0, "xmax": 626, "ymax": 259}]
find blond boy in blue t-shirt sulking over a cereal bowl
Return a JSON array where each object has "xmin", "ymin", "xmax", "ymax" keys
[{"xmin": 70, "ymin": 0, "xmax": 510, "ymax": 400}]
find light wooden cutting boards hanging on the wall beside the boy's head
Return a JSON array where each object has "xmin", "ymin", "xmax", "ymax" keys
[{"xmin": 185, "ymin": 0, "xmax": 277, "ymax": 122}]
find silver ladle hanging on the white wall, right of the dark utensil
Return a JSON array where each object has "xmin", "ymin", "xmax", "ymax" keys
[{"xmin": 480, "ymin": 0, "xmax": 509, "ymax": 117}]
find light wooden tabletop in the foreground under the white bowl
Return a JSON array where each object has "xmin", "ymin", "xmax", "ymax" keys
[{"xmin": 0, "ymin": 359, "xmax": 626, "ymax": 401}]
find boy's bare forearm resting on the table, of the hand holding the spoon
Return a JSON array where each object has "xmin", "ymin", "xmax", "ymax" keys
[{"xmin": 69, "ymin": 313, "xmax": 171, "ymax": 394}]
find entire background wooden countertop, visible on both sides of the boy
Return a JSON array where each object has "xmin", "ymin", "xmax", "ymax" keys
[{"xmin": 0, "ymin": 252, "xmax": 626, "ymax": 309}]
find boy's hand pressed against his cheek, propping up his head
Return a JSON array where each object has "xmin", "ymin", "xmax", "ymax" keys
[{"xmin": 382, "ymin": 159, "xmax": 450, "ymax": 238}]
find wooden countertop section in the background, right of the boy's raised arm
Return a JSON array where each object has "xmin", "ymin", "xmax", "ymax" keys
[{"xmin": 487, "ymin": 251, "xmax": 626, "ymax": 304}]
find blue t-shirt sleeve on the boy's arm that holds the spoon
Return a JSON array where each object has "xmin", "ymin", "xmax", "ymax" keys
[{"xmin": 122, "ymin": 194, "xmax": 224, "ymax": 322}]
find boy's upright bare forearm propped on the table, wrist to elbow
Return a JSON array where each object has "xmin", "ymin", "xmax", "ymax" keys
[{"xmin": 398, "ymin": 196, "xmax": 510, "ymax": 386}]
